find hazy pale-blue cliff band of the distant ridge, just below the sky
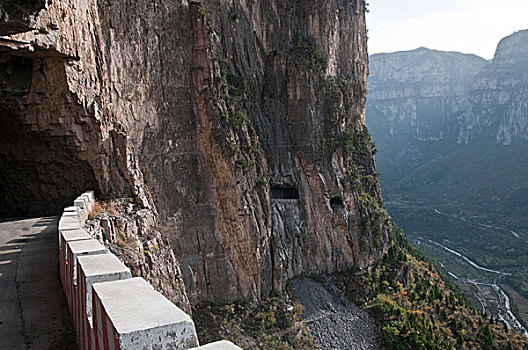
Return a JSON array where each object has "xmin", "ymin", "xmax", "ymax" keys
[{"xmin": 367, "ymin": 30, "xmax": 528, "ymax": 145}]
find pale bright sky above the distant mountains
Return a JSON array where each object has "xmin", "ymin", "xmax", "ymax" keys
[{"xmin": 367, "ymin": 0, "xmax": 528, "ymax": 59}]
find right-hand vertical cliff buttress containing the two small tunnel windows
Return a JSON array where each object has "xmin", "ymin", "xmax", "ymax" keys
[{"xmin": 177, "ymin": 1, "xmax": 386, "ymax": 298}]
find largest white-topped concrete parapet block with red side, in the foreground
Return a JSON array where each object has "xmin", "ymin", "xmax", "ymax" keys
[{"xmin": 92, "ymin": 278, "xmax": 198, "ymax": 350}]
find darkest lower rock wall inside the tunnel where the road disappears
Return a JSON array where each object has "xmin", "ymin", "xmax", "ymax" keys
[{"xmin": 0, "ymin": 109, "xmax": 95, "ymax": 217}]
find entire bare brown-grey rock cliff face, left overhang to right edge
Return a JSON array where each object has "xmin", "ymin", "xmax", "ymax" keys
[{"xmin": 0, "ymin": 0, "xmax": 388, "ymax": 302}]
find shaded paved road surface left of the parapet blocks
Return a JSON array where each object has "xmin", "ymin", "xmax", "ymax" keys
[{"xmin": 0, "ymin": 217, "xmax": 76, "ymax": 350}]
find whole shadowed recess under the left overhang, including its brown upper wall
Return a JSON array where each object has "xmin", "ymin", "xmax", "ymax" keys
[{"xmin": 0, "ymin": 50, "xmax": 104, "ymax": 216}]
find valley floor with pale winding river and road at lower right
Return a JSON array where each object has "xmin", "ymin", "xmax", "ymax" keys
[{"xmin": 387, "ymin": 198, "xmax": 528, "ymax": 336}]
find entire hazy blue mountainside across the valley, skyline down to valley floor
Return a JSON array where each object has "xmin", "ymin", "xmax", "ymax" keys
[{"xmin": 366, "ymin": 30, "xmax": 528, "ymax": 330}]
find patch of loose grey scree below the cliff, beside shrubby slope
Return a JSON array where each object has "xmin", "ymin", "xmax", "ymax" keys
[{"xmin": 290, "ymin": 278, "xmax": 381, "ymax": 350}]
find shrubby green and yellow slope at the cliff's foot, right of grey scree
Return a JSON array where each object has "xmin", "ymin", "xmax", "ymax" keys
[{"xmin": 336, "ymin": 226, "xmax": 528, "ymax": 349}]
